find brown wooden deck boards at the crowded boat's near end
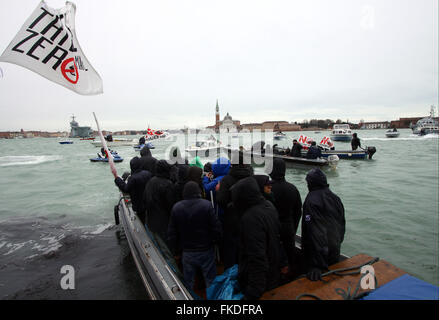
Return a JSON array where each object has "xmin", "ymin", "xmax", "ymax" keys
[{"xmin": 261, "ymin": 254, "xmax": 406, "ymax": 300}]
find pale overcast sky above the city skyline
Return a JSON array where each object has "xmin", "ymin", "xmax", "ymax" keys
[{"xmin": 0, "ymin": 0, "xmax": 439, "ymax": 131}]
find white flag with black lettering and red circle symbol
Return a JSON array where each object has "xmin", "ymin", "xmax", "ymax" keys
[{"xmin": 0, "ymin": 1, "xmax": 103, "ymax": 95}]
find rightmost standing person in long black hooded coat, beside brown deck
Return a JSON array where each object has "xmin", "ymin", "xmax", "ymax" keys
[{"xmin": 302, "ymin": 168, "xmax": 346, "ymax": 281}]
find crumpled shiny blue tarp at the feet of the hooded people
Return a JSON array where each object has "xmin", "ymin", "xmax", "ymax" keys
[{"xmin": 206, "ymin": 264, "xmax": 244, "ymax": 300}]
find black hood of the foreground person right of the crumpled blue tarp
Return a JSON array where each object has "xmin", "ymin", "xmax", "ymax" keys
[{"xmin": 230, "ymin": 177, "xmax": 264, "ymax": 213}]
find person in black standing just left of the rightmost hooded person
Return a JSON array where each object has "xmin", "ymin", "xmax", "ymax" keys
[{"xmin": 270, "ymin": 158, "xmax": 302, "ymax": 272}]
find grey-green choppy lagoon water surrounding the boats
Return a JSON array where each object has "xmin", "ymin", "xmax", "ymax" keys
[{"xmin": 0, "ymin": 129, "xmax": 439, "ymax": 299}]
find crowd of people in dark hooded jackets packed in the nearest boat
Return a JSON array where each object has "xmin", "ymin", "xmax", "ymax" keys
[{"xmin": 113, "ymin": 146, "xmax": 345, "ymax": 300}]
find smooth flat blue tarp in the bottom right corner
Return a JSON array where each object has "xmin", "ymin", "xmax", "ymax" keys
[{"xmin": 363, "ymin": 274, "xmax": 439, "ymax": 300}]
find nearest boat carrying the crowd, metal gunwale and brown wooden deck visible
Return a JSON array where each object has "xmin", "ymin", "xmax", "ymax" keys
[{"xmin": 114, "ymin": 189, "xmax": 438, "ymax": 301}]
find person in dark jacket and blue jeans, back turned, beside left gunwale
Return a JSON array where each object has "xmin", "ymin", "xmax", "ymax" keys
[{"xmin": 168, "ymin": 181, "xmax": 221, "ymax": 289}]
